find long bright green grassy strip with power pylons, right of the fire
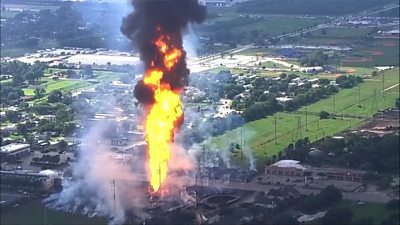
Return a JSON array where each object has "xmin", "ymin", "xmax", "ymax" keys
[{"xmin": 204, "ymin": 68, "xmax": 399, "ymax": 168}]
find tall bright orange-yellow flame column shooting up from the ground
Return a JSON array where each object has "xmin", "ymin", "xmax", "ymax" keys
[{"xmin": 144, "ymin": 30, "xmax": 183, "ymax": 192}]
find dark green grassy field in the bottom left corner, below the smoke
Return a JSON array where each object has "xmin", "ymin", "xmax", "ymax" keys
[{"xmin": 1, "ymin": 200, "xmax": 107, "ymax": 225}]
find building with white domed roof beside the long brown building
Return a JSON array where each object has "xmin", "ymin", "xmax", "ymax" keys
[{"xmin": 265, "ymin": 160, "xmax": 307, "ymax": 176}]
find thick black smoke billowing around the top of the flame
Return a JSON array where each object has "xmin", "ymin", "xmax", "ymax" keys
[{"xmin": 121, "ymin": 0, "xmax": 206, "ymax": 104}]
